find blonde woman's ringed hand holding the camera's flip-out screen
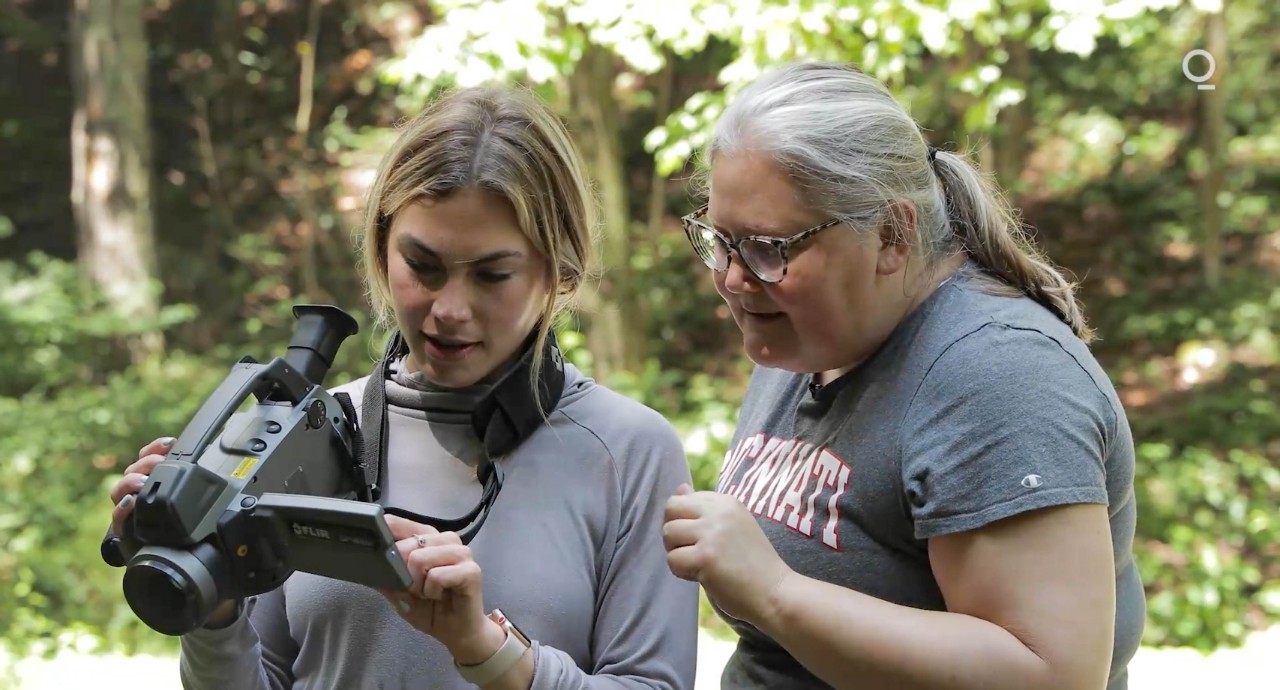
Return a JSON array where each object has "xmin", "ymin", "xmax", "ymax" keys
[{"xmin": 373, "ymin": 515, "xmax": 507, "ymax": 664}]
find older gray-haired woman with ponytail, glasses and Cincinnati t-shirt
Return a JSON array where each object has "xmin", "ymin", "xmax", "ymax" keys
[{"xmin": 663, "ymin": 63, "xmax": 1146, "ymax": 690}]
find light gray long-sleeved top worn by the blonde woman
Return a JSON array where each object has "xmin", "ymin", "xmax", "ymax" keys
[{"xmin": 180, "ymin": 365, "xmax": 698, "ymax": 690}]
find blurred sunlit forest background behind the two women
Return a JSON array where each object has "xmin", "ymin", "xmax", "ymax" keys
[{"xmin": 0, "ymin": 0, "xmax": 1280, "ymax": 675}]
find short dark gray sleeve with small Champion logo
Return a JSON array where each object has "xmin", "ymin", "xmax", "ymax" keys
[{"xmin": 899, "ymin": 323, "xmax": 1116, "ymax": 539}]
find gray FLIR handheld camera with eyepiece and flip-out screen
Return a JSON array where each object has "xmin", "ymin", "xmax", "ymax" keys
[{"xmin": 102, "ymin": 306, "xmax": 411, "ymax": 635}]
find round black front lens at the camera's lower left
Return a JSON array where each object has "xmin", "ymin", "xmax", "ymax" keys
[{"xmin": 124, "ymin": 547, "xmax": 219, "ymax": 635}]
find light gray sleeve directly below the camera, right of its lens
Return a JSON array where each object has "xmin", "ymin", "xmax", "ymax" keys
[{"xmin": 179, "ymin": 585, "xmax": 298, "ymax": 690}]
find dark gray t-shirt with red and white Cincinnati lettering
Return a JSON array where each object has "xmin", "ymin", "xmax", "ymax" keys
[{"xmin": 717, "ymin": 275, "xmax": 1146, "ymax": 690}]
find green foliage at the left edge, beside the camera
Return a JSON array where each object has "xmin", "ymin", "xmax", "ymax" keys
[{"xmin": 0, "ymin": 257, "xmax": 207, "ymax": 653}]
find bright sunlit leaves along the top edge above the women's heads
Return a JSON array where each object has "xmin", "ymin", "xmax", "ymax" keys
[{"xmin": 387, "ymin": 0, "xmax": 1172, "ymax": 174}]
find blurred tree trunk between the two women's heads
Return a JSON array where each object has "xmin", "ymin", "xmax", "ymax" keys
[{"xmin": 571, "ymin": 45, "xmax": 645, "ymax": 380}]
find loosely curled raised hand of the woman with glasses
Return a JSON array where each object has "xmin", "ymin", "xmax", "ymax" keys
[{"xmin": 662, "ymin": 484, "xmax": 794, "ymax": 623}]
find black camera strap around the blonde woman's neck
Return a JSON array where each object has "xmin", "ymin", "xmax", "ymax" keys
[{"xmin": 344, "ymin": 332, "xmax": 564, "ymax": 544}]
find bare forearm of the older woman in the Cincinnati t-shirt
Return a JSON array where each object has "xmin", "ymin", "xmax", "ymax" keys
[{"xmin": 756, "ymin": 574, "xmax": 1055, "ymax": 690}]
